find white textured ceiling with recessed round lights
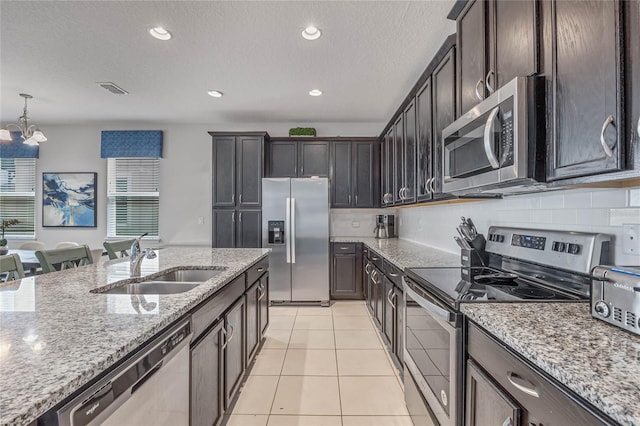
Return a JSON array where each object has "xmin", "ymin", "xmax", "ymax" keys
[{"xmin": 0, "ymin": 0, "xmax": 455, "ymax": 129}]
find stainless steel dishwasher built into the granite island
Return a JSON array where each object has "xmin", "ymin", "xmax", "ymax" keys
[{"xmin": 58, "ymin": 321, "xmax": 192, "ymax": 426}]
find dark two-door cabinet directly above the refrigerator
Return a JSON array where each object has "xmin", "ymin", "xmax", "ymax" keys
[{"xmin": 267, "ymin": 140, "xmax": 329, "ymax": 177}]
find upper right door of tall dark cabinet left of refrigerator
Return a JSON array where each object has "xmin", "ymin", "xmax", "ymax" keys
[{"xmin": 236, "ymin": 136, "xmax": 264, "ymax": 207}]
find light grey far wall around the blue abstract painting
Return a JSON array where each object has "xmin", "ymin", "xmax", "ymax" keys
[{"xmin": 9, "ymin": 123, "xmax": 384, "ymax": 248}]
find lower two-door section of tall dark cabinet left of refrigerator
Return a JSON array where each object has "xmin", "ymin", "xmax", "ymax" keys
[{"xmin": 213, "ymin": 209, "xmax": 262, "ymax": 248}]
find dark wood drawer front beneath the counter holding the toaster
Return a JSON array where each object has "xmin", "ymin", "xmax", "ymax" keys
[{"xmin": 467, "ymin": 323, "xmax": 611, "ymax": 426}]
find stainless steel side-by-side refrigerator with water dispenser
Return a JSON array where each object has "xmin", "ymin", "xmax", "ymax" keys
[{"xmin": 262, "ymin": 178, "xmax": 329, "ymax": 306}]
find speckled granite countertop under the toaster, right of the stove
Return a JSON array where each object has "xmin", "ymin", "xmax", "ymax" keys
[{"xmin": 461, "ymin": 303, "xmax": 640, "ymax": 425}]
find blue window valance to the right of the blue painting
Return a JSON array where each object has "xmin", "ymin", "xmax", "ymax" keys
[{"xmin": 100, "ymin": 130, "xmax": 162, "ymax": 158}]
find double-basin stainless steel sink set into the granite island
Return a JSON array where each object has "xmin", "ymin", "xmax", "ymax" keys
[{"xmin": 91, "ymin": 267, "xmax": 227, "ymax": 294}]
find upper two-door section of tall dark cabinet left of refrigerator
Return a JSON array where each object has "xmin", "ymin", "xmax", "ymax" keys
[{"xmin": 210, "ymin": 132, "xmax": 269, "ymax": 208}]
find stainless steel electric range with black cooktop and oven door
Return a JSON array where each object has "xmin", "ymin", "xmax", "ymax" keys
[{"xmin": 403, "ymin": 227, "xmax": 611, "ymax": 425}]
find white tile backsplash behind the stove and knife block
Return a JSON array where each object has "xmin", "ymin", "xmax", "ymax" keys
[{"xmin": 398, "ymin": 188, "xmax": 640, "ymax": 266}]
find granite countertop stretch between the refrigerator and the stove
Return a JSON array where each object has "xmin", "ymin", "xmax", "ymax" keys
[{"xmin": 331, "ymin": 237, "xmax": 460, "ymax": 269}]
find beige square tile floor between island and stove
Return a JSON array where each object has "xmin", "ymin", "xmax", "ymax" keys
[{"xmin": 227, "ymin": 301, "xmax": 413, "ymax": 426}]
